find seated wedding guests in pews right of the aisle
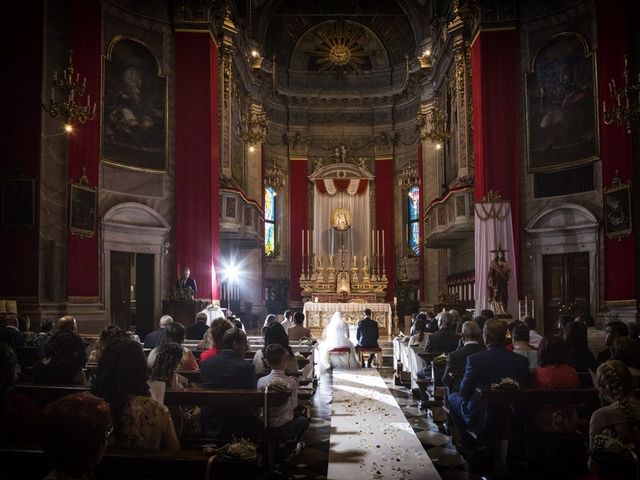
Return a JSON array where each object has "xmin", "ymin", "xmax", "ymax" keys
[{"xmin": 396, "ymin": 310, "xmax": 640, "ymax": 479}]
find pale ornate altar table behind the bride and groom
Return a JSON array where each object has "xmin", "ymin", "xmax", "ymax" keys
[{"xmin": 302, "ymin": 302, "xmax": 393, "ymax": 338}]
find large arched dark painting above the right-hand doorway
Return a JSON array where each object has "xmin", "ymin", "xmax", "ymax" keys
[{"xmin": 524, "ymin": 33, "xmax": 599, "ymax": 173}]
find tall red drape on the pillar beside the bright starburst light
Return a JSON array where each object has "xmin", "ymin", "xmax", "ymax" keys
[{"xmin": 175, "ymin": 31, "xmax": 220, "ymax": 298}]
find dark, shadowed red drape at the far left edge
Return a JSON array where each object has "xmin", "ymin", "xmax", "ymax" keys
[{"xmin": 0, "ymin": 2, "xmax": 43, "ymax": 298}]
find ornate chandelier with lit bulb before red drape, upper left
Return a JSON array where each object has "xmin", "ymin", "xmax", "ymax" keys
[{"xmin": 42, "ymin": 50, "xmax": 96, "ymax": 132}]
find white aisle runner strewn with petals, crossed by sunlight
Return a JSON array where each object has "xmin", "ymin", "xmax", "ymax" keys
[{"xmin": 327, "ymin": 368, "xmax": 440, "ymax": 480}]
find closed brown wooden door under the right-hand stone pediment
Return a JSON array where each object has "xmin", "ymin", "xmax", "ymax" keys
[{"xmin": 542, "ymin": 252, "xmax": 591, "ymax": 334}]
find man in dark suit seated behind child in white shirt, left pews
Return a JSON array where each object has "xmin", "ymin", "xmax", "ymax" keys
[{"xmin": 200, "ymin": 327, "xmax": 262, "ymax": 440}]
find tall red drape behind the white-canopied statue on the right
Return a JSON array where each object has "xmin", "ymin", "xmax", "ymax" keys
[{"xmin": 471, "ymin": 29, "xmax": 522, "ymax": 292}]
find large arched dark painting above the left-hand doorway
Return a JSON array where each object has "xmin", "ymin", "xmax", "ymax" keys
[{"xmin": 101, "ymin": 37, "xmax": 167, "ymax": 172}]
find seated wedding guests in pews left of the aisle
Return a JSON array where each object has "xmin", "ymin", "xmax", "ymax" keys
[{"xmin": 0, "ymin": 310, "xmax": 313, "ymax": 479}]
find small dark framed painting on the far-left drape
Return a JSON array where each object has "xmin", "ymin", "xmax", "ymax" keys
[{"xmin": 2, "ymin": 178, "xmax": 36, "ymax": 227}]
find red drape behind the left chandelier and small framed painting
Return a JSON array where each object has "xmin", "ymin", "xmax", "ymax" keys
[{"xmin": 67, "ymin": 0, "xmax": 102, "ymax": 297}]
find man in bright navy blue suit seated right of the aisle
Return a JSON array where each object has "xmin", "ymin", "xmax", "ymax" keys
[{"xmin": 447, "ymin": 319, "xmax": 529, "ymax": 440}]
